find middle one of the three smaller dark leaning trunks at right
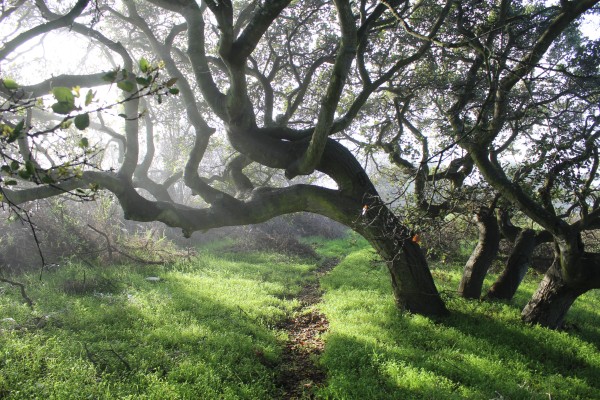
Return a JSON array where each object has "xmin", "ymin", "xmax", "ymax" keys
[{"xmin": 486, "ymin": 229, "xmax": 537, "ymax": 300}]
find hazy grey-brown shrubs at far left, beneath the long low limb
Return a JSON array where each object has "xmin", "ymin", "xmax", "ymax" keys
[{"xmin": 0, "ymin": 197, "xmax": 192, "ymax": 274}]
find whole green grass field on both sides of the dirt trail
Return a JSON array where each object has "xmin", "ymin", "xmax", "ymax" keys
[{"xmin": 0, "ymin": 237, "xmax": 600, "ymax": 399}]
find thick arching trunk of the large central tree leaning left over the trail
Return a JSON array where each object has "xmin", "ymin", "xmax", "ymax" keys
[{"xmin": 228, "ymin": 126, "xmax": 448, "ymax": 315}]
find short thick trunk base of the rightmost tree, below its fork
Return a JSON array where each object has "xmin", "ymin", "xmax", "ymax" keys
[{"xmin": 521, "ymin": 258, "xmax": 588, "ymax": 329}]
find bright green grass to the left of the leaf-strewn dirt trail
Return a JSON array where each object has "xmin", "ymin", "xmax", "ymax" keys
[{"xmin": 0, "ymin": 248, "xmax": 315, "ymax": 399}]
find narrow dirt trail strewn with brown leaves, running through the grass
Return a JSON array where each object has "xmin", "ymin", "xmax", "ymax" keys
[{"xmin": 278, "ymin": 259, "xmax": 339, "ymax": 400}]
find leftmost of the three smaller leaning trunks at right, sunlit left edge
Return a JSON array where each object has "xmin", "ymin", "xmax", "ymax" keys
[{"xmin": 458, "ymin": 207, "xmax": 500, "ymax": 299}]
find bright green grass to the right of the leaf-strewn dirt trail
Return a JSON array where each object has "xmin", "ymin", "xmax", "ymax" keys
[{"xmin": 319, "ymin": 248, "xmax": 600, "ymax": 399}]
